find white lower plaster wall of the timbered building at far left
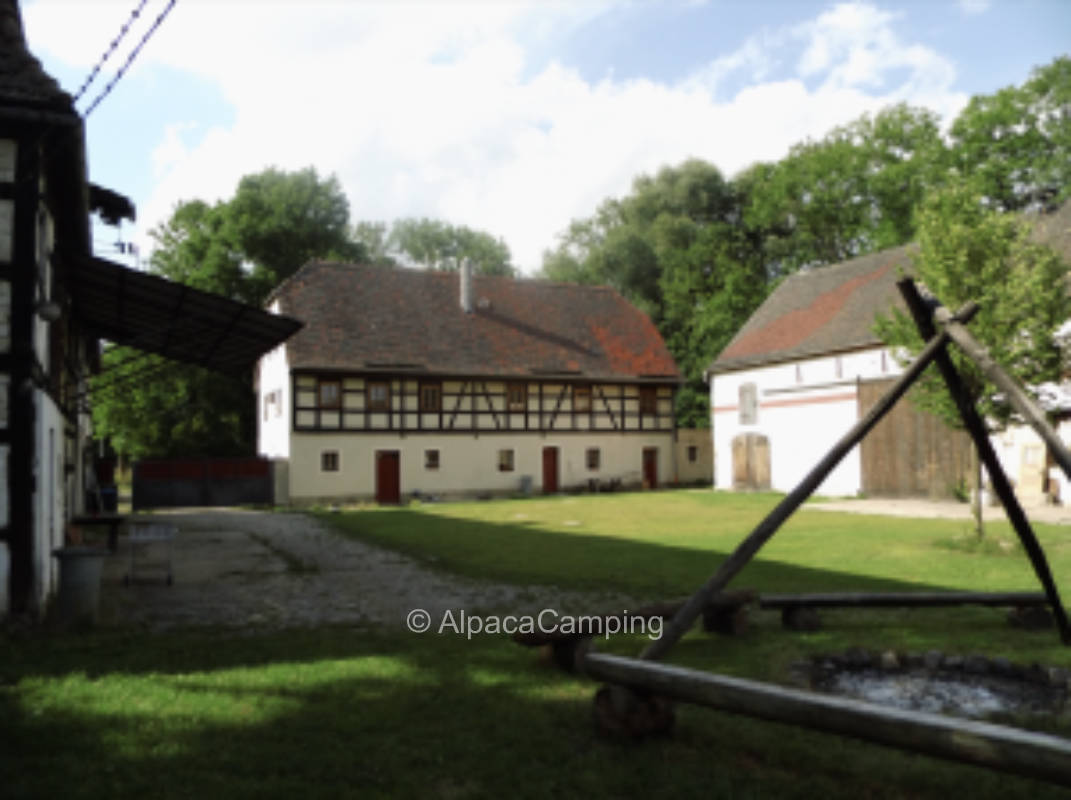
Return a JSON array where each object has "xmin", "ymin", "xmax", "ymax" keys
[{"xmin": 33, "ymin": 391, "xmax": 66, "ymax": 612}]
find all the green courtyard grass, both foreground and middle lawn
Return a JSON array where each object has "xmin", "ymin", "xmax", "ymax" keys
[{"xmin": 0, "ymin": 493, "xmax": 1071, "ymax": 800}]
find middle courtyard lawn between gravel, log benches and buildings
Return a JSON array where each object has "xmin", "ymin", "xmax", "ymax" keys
[{"xmin": 312, "ymin": 490, "xmax": 1071, "ymax": 598}]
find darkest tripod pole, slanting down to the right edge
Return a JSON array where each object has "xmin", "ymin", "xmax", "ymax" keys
[{"xmin": 896, "ymin": 277, "xmax": 1071, "ymax": 645}]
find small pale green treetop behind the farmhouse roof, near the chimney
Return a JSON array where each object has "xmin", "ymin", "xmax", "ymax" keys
[{"xmin": 387, "ymin": 217, "xmax": 515, "ymax": 277}]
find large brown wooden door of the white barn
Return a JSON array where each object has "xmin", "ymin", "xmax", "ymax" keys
[{"xmin": 859, "ymin": 378, "xmax": 972, "ymax": 498}]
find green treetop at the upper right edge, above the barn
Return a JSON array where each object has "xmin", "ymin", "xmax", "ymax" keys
[{"xmin": 950, "ymin": 56, "xmax": 1071, "ymax": 211}]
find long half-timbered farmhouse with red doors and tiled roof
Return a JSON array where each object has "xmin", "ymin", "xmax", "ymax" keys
[{"xmin": 257, "ymin": 261, "xmax": 679, "ymax": 502}]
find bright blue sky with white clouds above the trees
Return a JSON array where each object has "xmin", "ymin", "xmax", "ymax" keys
[{"xmin": 16, "ymin": 0, "xmax": 1071, "ymax": 272}]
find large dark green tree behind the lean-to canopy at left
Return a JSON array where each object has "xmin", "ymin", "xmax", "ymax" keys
[{"xmin": 93, "ymin": 168, "xmax": 365, "ymax": 458}]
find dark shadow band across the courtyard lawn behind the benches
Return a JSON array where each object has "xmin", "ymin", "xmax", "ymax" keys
[{"xmin": 317, "ymin": 498, "xmax": 1040, "ymax": 600}]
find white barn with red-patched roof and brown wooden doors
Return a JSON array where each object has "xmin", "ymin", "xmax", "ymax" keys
[{"xmin": 706, "ymin": 203, "xmax": 1071, "ymax": 504}]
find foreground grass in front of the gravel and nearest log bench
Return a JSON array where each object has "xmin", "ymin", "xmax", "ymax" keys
[{"xmin": 0, "ymin": 630, "xmax": 1059, "ymax": 798}]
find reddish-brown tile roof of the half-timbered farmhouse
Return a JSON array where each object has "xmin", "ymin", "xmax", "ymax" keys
[{"xmin": 269, "ymin": 261, "xmax": 680, "ymax": 380}]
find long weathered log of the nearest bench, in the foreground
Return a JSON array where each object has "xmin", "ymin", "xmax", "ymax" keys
[{"xmin": 580, "ymin": 652, "xmax": 1071, "ymax": 786}]
